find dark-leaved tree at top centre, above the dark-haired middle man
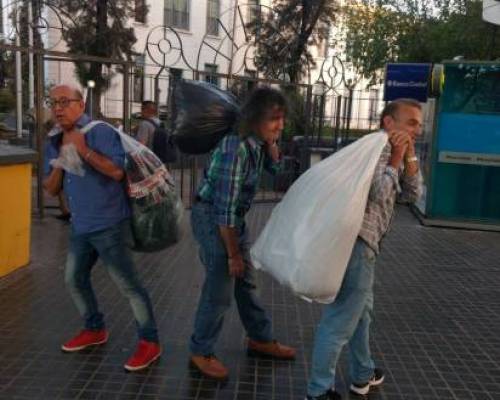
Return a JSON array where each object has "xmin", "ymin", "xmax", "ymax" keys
[{"xmin": 249, "ymin": 0, "xmax": 338, "ymax": 83}]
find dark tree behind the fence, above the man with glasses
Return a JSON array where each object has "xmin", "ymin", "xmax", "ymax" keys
[{"xmin": 52, "ymin": 0, "xmax": 148, "ymax": 115}]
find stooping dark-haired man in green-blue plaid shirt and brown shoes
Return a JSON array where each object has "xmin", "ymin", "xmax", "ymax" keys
[{"xmin": 190, "ymin": 88, "xmax": 295, "ymax": 379}]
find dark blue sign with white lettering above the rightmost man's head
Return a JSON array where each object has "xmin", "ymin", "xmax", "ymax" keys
[{"xmin": 384, "ymin": 64, "xmax": 431, "ymax": 103}]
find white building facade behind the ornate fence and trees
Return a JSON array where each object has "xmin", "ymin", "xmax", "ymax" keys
[{"xmin": 42, "ymin": 0, "xmax": 382, "ymax": 120}]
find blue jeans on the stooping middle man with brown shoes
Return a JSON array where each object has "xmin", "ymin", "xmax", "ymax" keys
[{"xmin": 190, "ymin": 203, "xmax": 272, "ymax": 355}]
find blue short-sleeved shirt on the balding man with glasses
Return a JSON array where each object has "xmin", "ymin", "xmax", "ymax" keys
[{"xmin": 45, "ymin": 115, "xmax": 130, "ymax": 234}]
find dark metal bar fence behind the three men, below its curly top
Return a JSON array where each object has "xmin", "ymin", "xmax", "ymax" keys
[{"xmin": 0, "ymin": 45, "xmax": 383, "ymax": 215}]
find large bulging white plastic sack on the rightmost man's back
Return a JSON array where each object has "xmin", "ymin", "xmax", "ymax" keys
[{"xmin": 250, "ymin": 132, "xmax": 387, "ymax": 303}]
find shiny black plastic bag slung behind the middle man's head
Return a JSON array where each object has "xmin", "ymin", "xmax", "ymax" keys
[{"xmin": 174, "ymin": 80, "xmax": 240, "ymax": 154}]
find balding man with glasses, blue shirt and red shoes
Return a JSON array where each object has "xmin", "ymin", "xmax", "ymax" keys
[{"xmin": 43, "ymin": 85, "xmax": 161, "ymax": 371}]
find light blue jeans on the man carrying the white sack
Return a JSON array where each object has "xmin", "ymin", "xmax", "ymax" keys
[{"xmin": 307, "ymin": 238, "xmax": 376, "ymax": 396}]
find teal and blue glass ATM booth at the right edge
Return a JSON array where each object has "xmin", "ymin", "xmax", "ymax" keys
[{"xmin": 416, "ymin": 61, "xmax": 500, "ymax": 231}]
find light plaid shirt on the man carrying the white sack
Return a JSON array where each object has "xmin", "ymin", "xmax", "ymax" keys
[{"xmin": 359, "ymin": 142, "xmax": 423, "ymax": 254}]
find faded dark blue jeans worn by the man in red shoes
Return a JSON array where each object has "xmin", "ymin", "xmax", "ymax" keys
[{"xmin": 65, "ymin": 219, "xmax": 158, "ymax": 342}]
